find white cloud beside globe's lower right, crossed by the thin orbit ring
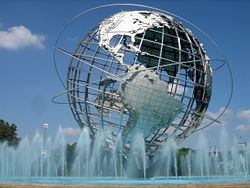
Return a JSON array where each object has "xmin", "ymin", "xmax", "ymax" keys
[{"xmin": 203, "ymin": 107, "xmax": 233, "ymax": 126}]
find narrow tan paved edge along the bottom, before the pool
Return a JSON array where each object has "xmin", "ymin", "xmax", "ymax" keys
[{"xmin": 0, "ymin": 183, "xmax": 250, "ymax": 188}]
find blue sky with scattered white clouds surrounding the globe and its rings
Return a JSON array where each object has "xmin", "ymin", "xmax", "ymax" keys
[{"xmin": 0, "ymin": 0, "xmax": 250, "ymax": 149}]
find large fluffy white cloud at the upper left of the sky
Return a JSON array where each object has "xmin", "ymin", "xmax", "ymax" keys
[{"xmin": 0, "ymin": 26, "xmax": 46, "ymax": 50}]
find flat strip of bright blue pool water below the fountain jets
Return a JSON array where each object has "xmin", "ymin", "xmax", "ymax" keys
[{"xmin": 0, "ymin": 176, "xmax": 250, "ymax": 185}]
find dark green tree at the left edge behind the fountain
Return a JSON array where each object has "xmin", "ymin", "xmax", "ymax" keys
[{"xmin": 0, "ymin": 120, "xmax": 21, "ymax": 146}]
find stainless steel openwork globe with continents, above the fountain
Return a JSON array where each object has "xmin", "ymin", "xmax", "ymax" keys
[{"xmin": 63, "ymin": 11, "xmax": 212, "ymax": 154}]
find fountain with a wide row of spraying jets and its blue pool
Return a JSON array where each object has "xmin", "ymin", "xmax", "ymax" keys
[{"xmin": 0, "ymin": 127, "xmax": 250, "ymax": 185}]
